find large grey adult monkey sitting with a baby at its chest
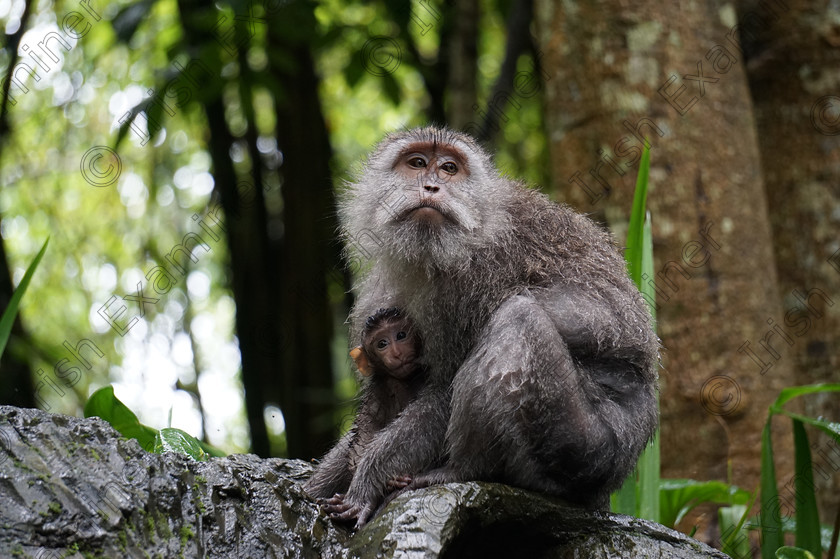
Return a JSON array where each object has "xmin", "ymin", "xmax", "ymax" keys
[{"xmin": 328, "ymin": 127, "xmax": 659, "ymax": 527}]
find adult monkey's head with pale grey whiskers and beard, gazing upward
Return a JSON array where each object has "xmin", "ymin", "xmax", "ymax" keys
[{"xmin": 340, "ymin": 127, "xmax": 514, "ymax": 272}]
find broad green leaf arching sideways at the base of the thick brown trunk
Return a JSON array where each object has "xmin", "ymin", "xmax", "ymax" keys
[{"xmin": 659, "ymin": 479, "xmax": 752, "ymax": 528}]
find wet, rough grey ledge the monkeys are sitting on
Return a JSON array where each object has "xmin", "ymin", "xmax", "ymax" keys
[{"xmin": 0, "ymin": 406, "xmax": 726, "ymax": 559}]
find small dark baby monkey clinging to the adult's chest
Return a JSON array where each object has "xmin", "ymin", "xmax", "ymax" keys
[{"xmin": 304, "ymin": 307, "xmax": 426, "ymax": 520}]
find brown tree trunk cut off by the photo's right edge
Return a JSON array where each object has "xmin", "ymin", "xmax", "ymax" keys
[{"xmin": 738, "ymin": 0, "xmax": 840, "ymax": 519}]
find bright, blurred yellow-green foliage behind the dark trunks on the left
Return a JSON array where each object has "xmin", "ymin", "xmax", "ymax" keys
[{"xmin": 0, "ymin": 0, "xmax": 546, "ymax": 457}]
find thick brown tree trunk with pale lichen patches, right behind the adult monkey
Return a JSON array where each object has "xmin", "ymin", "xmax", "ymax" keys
[{"xmin": 535, "ymin": 0, "xmax": 793, "ymax": 532}]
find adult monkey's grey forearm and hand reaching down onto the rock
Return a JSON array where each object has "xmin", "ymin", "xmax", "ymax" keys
[{"xmin": 324, "ymin": 386, "xmax": 450, "ymax": 528}]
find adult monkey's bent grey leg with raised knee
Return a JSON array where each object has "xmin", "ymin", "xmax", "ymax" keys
[{"xmin": 420, "ymin": 294, "xmax": 655, "ymax": 506}]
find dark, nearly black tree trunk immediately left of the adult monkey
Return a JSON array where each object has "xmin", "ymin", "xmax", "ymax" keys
[{"xmin": 268, "ymin": 2, "xmax": 340, "ymax": 459}]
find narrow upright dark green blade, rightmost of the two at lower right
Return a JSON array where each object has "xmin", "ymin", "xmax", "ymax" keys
[{"xmin": 796, "ymin": 419, "xmax": 822, "ymax": 556}]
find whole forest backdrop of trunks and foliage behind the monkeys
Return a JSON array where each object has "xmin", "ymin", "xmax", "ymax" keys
[{"xmin": 0, "ymin": 0, "xmax": 840, "ymax": 552}]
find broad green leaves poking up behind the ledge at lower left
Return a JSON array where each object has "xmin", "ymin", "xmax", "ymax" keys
[{"xmin": 85, "ymin": 386, "xmax": 225, "ymax": 461}]
